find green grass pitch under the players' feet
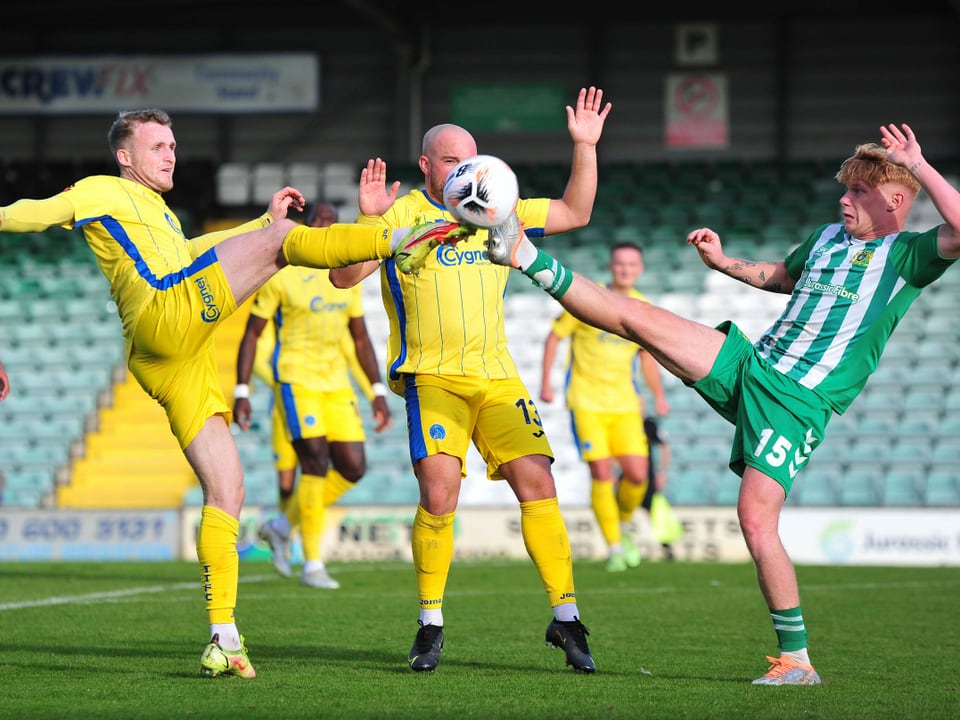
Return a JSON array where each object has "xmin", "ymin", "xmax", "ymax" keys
[{"xmin": 0, "ymin": 561, "xmax": 960, "ymax": 720}]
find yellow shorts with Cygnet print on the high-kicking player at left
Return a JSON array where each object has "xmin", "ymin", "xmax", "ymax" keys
[{"xmin": 127, "ymin": 254, "xmax": 237, "ymax": 449}]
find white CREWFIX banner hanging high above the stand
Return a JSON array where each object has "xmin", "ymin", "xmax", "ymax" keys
[{"xmin": 0, "ymin": 53, "xmax": 320, "ymax": 115}]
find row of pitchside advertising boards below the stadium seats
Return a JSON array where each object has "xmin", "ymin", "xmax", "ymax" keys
[{"xmin": 0, "ymin": 506, "xmax": 960, "ymax": 567}]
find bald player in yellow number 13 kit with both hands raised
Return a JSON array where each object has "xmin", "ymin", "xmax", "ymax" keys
[{"xmin": 331, "ymin": 87, "xmax": 611, "ymax": 672}]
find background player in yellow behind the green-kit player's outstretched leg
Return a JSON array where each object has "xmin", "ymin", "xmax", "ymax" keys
[{"xmin": 540, "ymin": 243, "xmax": 670, "ymax": 572}]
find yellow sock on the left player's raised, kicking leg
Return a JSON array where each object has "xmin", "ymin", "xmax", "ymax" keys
[{"xmin": 283, "ymin": 224, "xmax": 393, "ymax": 268}]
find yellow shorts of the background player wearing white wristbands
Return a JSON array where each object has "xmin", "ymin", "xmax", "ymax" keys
[{"xmin": 274, "ymin": 383, "xmax": 366, "ymax": 442}]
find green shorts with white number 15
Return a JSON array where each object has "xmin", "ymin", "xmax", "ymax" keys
[{"xmin": 691, "ymin": 321, "xmax": 833, "ymax": 495}]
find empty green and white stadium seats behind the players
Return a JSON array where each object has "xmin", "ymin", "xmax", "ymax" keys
[{"xmin": 0, "ymin": 161, "xmax": 960, "ymax": 507}]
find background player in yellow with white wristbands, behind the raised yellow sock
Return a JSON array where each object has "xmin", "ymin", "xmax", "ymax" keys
[{"xmin": 234, "ymin": 204, "xmax": 392, "ymax": 589}]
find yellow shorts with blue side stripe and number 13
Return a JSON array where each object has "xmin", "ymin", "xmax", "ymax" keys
[{"xmin": 401, "ymin": 375, "xmax": 553, "ymax": 480}]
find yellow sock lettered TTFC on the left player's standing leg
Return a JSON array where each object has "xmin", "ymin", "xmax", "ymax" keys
[{"xmin": 197, "ymin": 505, "xmax": 240, "ymax": 625}]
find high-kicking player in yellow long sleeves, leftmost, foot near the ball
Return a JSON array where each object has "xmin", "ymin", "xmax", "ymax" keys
[{"xmin": 0, "ymin": 109, "xmax": 457, "ymax": 678}]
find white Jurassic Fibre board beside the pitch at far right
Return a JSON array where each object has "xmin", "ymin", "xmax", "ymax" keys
[{"xmin": 780, "ymin": 508, "xmax": 960, "ymax": 566}]
